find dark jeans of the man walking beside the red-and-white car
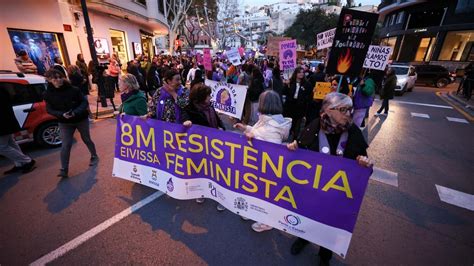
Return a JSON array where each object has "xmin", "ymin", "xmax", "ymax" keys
[{"xmin": 59, "ymin": 119, "xmax": 97, "ymax": 170}]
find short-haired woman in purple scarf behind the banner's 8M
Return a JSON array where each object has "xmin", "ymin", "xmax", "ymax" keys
[{"xmin": 148, "ymin": 70, "xmax": 189, "ymax": 124}]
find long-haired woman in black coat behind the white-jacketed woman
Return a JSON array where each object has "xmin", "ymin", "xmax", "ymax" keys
[{"xmin": 283, "ymin": 67, "xmax": 312, "ymax": 139}]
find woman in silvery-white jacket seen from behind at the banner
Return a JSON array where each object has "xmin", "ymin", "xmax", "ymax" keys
[{"xmin": 234, "ymin": 90, "xmax": 291, "ymax": 233}]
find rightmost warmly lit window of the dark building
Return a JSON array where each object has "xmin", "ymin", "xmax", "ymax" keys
[{"xmin": 438, "ymin": 31, "xmax": 474, "ymax": 61}]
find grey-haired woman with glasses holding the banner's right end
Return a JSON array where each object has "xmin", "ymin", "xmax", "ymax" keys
[{"xmin": 287, "ymin": 92, "xmax": 372, "ymax": 265}]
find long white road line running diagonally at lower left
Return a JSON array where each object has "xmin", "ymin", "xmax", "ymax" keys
[{"xmin": 30, "ymin": 191, "xmax": 163, "ymax": 265}]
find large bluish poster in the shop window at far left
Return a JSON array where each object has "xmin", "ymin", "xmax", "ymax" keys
[{"xmin": 7, "ymin": 29, "xmax": 64, "ymax": 75}]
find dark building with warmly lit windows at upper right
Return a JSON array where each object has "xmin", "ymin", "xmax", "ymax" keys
[{"xmin": 379, "ymin": 0, "xmax": 474, "ymax": 71}]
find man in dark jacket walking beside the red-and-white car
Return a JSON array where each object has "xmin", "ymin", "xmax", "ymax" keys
[{"xmin": 44, "ymin": 69, "xmax": 99, "ymax": 178}]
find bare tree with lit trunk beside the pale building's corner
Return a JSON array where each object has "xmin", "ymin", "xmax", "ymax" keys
[{"xmin": 164, "ymin": 0, "xmax": 192, "ymax": 52}]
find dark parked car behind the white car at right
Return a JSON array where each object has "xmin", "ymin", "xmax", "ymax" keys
[{"xmin": 415, "ymin": 65, "xmax": 453, "ymax": 88}]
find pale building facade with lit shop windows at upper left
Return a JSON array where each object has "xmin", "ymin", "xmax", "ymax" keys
[{"xmin": 0, "ymin": 0, "xmax": 168, "ymax": 74}]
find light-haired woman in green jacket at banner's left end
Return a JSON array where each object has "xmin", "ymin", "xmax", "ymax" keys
[{"xmin": 119, "ymin": 74, "xmax": 147, "ymax": 116}]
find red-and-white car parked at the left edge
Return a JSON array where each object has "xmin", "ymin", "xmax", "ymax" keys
[{"xmin": 0, "ymin": 71, "xmax": 61, "ymax": 147}]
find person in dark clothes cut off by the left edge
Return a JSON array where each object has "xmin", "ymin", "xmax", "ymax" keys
[{"xmin": 0, "ymin": 90, "xmax": 36, "ymax": 175}]
